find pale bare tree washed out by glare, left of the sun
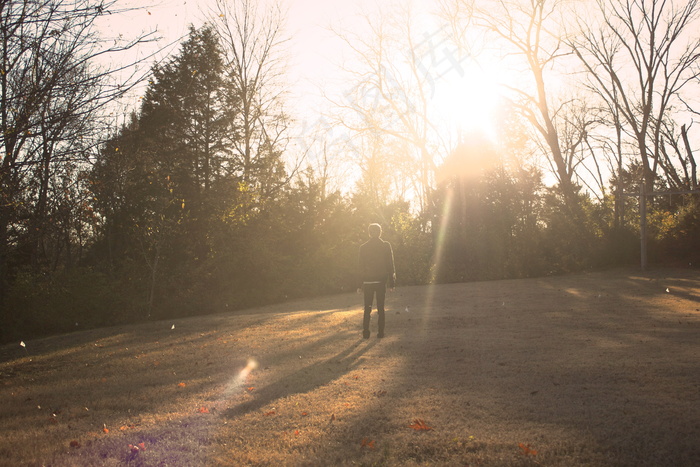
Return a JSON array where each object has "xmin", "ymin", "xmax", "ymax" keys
[{"xmin": 331, "ymin": 2, "xmax": 448, "ymax": 215}]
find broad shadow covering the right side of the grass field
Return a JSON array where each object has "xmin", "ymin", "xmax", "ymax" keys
[{"xmin": 346, "ymin": 272, "xmax": 700, "ymax": 465}]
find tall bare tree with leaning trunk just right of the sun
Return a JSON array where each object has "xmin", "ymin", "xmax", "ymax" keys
[{"xmin": 443, "ymin": 0, "xmax": 588, "ymax": 206}]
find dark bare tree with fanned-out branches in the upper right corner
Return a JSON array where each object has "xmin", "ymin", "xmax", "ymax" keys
[{"xmin": 569, "ymin": 0, "xmax": 700, "ymax": 192}]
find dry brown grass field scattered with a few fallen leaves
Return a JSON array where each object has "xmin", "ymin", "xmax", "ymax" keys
[{"xmin": 0, "ymin": 270, "xmax": 700, "ymax": 466}]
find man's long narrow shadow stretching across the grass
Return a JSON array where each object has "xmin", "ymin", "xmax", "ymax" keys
[{"xmin": 223, "ymin": 339, "xmax": 377, "ymax": 418}]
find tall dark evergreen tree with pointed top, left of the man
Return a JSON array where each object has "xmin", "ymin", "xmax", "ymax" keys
[{"xmin": 92, "ymin": 26, "xmax": 232, "ymax": 316}]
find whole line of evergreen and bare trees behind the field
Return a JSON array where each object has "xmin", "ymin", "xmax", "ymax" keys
[{"xmin": 0, "ymin": 0, "xmax": 700, "ymax": 341}]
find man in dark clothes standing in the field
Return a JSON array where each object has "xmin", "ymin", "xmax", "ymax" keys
[{"xmin": 358, "ymin": 224, "xmax": 396, "ymax": 339}]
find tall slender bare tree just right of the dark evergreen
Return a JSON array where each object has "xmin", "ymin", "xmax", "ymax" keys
[{"xmin": 212, "ymin": 0, "xmax": 289, "ymax": 198}]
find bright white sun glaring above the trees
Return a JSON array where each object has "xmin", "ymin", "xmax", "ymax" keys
[{"xmin": 433, "ymin": 62, "xmax": 504, "ymax": 140}]
